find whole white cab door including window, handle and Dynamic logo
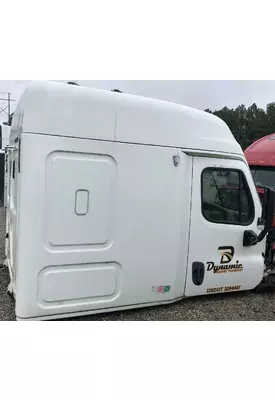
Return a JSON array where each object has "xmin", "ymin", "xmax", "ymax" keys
[{"xmin": 185, "ymin": 157, "xmax": 264, "ymax": 296}]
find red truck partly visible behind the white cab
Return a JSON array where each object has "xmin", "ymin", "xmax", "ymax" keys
[{"xmin": 244, "ymin": 133, "xmax": 275, "ymax": 262}]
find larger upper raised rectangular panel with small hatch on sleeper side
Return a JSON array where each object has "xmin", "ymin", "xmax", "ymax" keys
[{"xmin": 44, "ymin": 152, "xmax": 116, "ymax": 248}]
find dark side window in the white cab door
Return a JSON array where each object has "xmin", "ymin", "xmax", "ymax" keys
[{"xmin": 202, "ymin": 168, "xmax": 254, "ymax": 225}]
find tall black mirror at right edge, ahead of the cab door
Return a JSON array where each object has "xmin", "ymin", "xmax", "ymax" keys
[{"xmin": 257, "ymin": 188, "xmax": 275, "ymax": 242}]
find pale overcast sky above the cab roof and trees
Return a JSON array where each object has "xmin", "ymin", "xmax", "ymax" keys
[{"xmin": 0, "ymin": 79, "xmax": 275, "ymax": 121}]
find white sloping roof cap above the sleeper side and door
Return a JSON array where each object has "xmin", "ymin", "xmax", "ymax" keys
[{"xmin": 11, "ymin": 81, "xmax": 243, "ymax": 154}]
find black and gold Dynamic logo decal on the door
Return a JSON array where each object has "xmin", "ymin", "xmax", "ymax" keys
[{"xmin": 206, "ymin": 246, "xmax": 243, "ymax": 274}]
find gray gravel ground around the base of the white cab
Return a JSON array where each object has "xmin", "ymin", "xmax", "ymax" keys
[{"xmin": 0, "ymin": 209, "xmax": 275, "ymax": 321}]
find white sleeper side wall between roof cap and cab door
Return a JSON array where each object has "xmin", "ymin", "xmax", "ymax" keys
[{"xmin": 16, "ymin": 134, "xmax": 192, "ymax": 319}]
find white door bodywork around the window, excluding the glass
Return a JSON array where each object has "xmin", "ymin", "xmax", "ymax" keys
[{"xmin": 185, "ymin": 157, "xmax": 265, "ymax": 296}]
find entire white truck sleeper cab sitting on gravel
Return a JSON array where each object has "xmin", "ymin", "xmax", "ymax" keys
[{"xmin": 3, "ymin": 82, "xmax": 274, "ymax": 320}]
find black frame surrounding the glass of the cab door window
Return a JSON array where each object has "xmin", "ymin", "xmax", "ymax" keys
[{"xmin": 201, "ymin": 167, "xmax": 255, "ymax": 226}]
